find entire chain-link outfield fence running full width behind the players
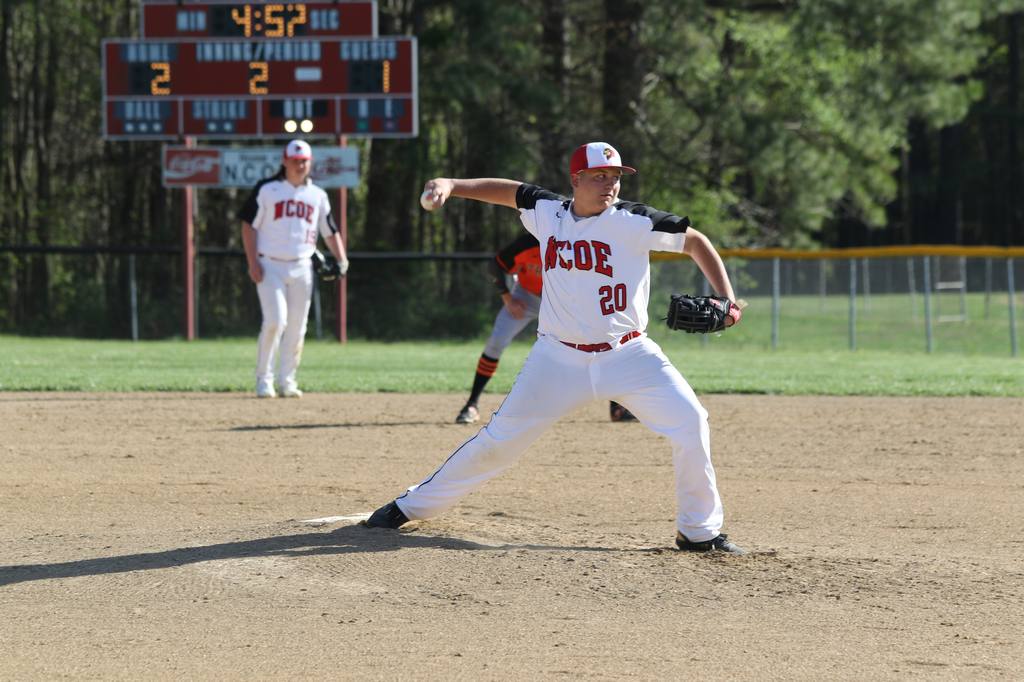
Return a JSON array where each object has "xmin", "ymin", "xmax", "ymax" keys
[{"xmin": 0, "ymin": 247, "xmax": 1024, "ymax": 356}]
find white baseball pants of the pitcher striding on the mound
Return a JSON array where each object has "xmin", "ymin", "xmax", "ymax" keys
[{"xmin": 396, "ymin": 336, "xmax": 723, "ymax": 542}]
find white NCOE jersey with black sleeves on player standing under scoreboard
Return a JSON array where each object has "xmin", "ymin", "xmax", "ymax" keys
[{"xmin": 239, "ymin": 173, "xmax": 338, "ymax": 260}]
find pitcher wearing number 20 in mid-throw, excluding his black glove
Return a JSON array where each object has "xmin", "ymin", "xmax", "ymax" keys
[{"xmin": 366, "ymin": 142, "xmax": 742, "ymax": 553}]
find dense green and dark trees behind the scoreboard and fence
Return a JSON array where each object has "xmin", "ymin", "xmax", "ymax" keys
[{"xmin": 0, "ymin": 0, "xmax": 1024, "ymax": 337}]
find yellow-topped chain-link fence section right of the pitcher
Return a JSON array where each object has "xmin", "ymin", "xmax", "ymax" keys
[{"xmin": 652, "ymin": 247, "xmax": 1024, "ymax": 356}]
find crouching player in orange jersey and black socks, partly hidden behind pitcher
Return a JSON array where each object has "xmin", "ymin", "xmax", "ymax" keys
[{"xmin": 455, "ymin": 233, "xmax": 636, "ymax": 424}]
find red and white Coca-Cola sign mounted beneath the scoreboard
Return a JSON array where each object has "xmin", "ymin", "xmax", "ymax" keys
[{"xmin": 163, "ymin": 145, "xmax": 359, "ymax": 188}]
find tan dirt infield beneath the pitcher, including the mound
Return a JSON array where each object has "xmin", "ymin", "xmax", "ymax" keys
[{"xmin": 0, "ymin": 393, "xmax": 1024, "ymax": 680}]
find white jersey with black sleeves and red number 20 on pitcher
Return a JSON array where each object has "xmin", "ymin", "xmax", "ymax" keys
[{"xmin": 516, "ymin": 183, "xmax": 690, "ymax": 344}]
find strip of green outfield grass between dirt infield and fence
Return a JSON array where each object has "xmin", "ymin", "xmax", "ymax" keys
[{"xmin": 0, "ymin": 331, "xmax": 1024, "ymax": 397}]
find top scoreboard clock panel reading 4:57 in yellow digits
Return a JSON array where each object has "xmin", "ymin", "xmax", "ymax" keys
[{"xmin": 142, "ymin": 0, "xmax": 377, "ymax": 38}]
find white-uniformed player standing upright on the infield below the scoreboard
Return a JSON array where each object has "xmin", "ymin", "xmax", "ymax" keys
[{"xmin": 239, "ymin": 139, "xmax": 348, "ymax": 397}]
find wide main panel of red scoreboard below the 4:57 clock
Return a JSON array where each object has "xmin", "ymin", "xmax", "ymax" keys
[{"xmin": 102, "ymin": 37, "xmax": 419, "ymax": 139}]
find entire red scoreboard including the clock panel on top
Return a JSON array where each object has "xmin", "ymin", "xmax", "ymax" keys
[{"xmin": 101, "ymin": 0, "xmax": 419, "ymax": 139}]
